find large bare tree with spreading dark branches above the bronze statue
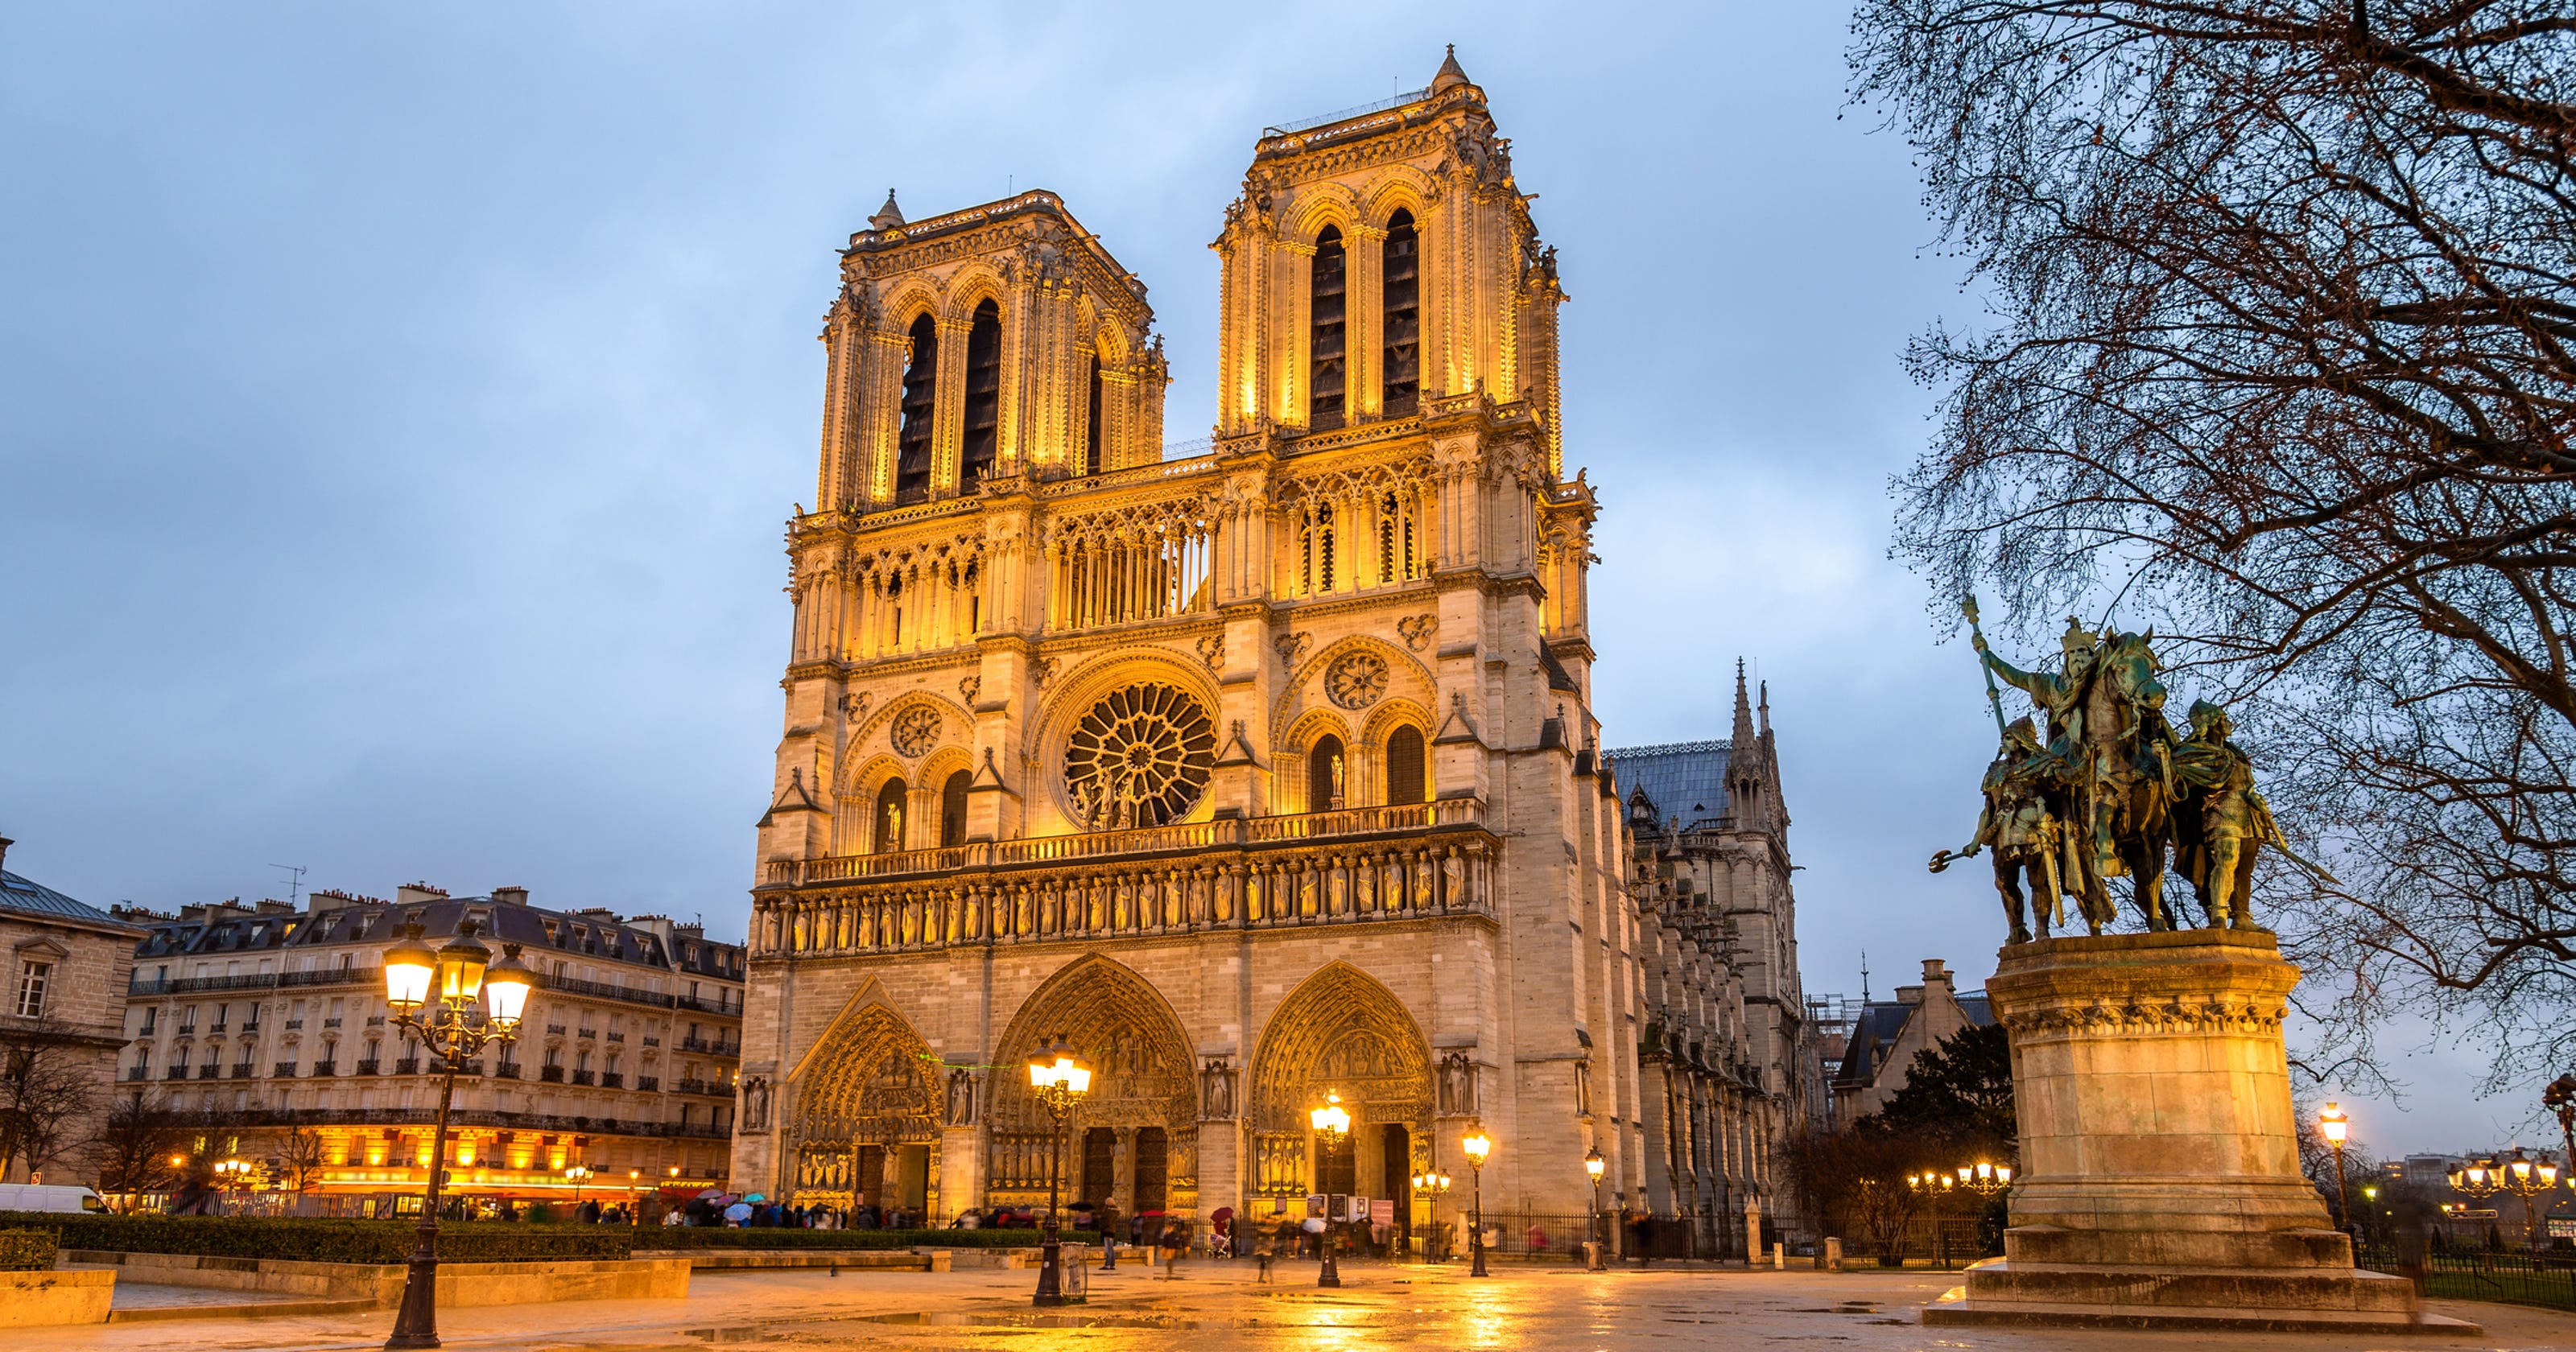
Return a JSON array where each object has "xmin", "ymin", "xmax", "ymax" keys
[{"xmin": 1852, "ymin": 0, "xmax": 2576, "ymax": 1084}]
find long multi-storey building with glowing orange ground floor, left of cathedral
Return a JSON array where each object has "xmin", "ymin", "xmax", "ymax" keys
[{"xmin": 118, "ymin": 884, "xmax": 742, "ymax": 1200}]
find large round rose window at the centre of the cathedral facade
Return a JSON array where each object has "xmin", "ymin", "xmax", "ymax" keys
[{"xmin": 1064, "ymin": 685, "xmax": 1216, "ymax": 832}]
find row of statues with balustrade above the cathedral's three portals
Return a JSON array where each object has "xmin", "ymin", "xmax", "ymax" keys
[{"xmin": 752, "ymin": 798, "xmax": 1502, "ymax": 958}]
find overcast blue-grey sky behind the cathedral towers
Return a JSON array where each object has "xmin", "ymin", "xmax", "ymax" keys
[{"xmin": 0, "ymin": 2, "xmax": 2522, "ymax": 1148}]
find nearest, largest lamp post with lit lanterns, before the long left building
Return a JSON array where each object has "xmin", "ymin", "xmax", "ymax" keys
[{"xmin": 384, "ymin": 919, "xmax": 536, "ymax": 1347}]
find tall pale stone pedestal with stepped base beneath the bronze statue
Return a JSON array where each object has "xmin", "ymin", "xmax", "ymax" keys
[{"xmin": 1922, "ymin": 930, "xmax": 2473, "ymax": 1334}]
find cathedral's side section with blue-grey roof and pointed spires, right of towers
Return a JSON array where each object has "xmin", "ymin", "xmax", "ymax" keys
[{"xmin": 1602, "ymin": 667, "xmax": 1827, "ymax": 1251}]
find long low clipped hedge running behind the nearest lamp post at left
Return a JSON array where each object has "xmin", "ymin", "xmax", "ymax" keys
[{"xmin": 0, "ymin": 1213, "xmax": 634, "ymax": 1264}]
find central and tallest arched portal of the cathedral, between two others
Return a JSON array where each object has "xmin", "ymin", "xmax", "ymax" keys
[{"xmin": 984, "ymin": 955, "xmax": 1198, "ymax": 1215}]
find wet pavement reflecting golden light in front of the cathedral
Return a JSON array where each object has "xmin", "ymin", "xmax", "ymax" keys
[{"xmin": 10, "ymin": 1262, "xmax": 2576, "ymax": 1352}]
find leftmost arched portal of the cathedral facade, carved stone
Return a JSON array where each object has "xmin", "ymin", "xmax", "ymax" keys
[{"xmin": 783, "ymin": 1004, "xmax": 940, "ymax": 1215}]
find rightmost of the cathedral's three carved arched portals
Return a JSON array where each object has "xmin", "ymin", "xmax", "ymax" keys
[{"xmin": 1247, "ymin": 963, "xmax": 1432, "ymax": 1197}]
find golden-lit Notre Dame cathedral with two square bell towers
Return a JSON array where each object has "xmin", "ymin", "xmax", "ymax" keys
[{"xmin": 732, "ymin": 56, "xmax": 1803, "ymax": 1249}]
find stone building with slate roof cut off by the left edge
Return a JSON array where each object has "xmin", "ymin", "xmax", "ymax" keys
[{"xmin": 0, "ymin": 837, "xmax": 142, "ymax": 1182}]
